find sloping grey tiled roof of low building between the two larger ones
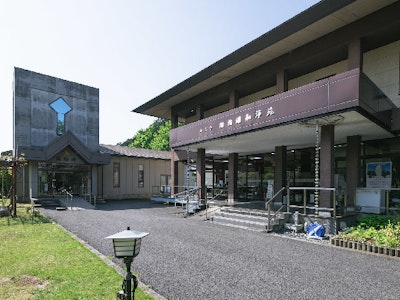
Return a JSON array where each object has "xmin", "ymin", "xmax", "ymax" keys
[{"xmin": 99, "ymin": 144, "xmax": 171, "ymax": 160}]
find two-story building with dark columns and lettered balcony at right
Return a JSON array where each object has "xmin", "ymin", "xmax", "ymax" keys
[{"xmin": 134, "ymin": 0, "xmax": 400, "ymax": 218}]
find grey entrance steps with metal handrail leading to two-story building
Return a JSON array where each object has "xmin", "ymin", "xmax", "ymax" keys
[{"xmin": 210, "ymin": 207, "xmax": 290, "ymax": 232}]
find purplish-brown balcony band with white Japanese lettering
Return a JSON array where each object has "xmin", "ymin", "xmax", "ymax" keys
[{"xmin": 170, "ymin": 69, "xmax": 360, "ymax": 148}]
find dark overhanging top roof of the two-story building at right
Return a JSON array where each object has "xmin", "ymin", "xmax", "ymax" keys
[{"xmin": 133, "ymin": 0, "xmax": 399, "ymax": 119}]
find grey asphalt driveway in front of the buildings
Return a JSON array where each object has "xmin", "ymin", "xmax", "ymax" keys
[{"xmin": 39, "ymin": 200, "xmax": 400, "ymax": 300}]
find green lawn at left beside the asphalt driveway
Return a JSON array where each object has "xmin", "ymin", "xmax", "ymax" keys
[{"xmin": 0, "ymin": 200, "xmax": 153, "ymax": 300}]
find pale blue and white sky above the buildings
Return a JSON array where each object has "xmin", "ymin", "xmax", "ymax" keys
[{"xmin": 0, "ymin": 0, "xmax": 318, "ymax": 151}]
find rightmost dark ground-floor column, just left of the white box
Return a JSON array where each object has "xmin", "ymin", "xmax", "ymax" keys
[{"xmin": 346, "ymin": 135, "xmax": 361, "ymax": 206}]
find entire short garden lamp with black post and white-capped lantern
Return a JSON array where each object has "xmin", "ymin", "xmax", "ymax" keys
[{"xmin": 106, "ymin": 227, "xmax": 148, "ymax": 300}]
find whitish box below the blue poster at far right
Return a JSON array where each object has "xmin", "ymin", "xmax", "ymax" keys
[{"xmin": 356, "ymin": 188, "xmax": 385, "ymax": 214}]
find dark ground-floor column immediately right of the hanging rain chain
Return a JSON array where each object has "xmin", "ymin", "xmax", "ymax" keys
[{"xmin": 319, "ymin": 125, "xmax": 335, "ymax": 207}]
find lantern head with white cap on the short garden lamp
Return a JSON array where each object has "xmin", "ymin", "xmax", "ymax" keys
[{"xmin": 106, "ymin": 230, "xmax": 148, "ymax": 258}]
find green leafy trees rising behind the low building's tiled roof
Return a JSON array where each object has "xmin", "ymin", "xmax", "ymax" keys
[{"xmin": 119, "ymin": 118, "xmax": 171, "ymax": 151}]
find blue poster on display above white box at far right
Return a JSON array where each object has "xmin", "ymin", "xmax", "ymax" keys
[{"xmin": 366, "ymin": 161, "xmax": 392, "ymax": 189}]
